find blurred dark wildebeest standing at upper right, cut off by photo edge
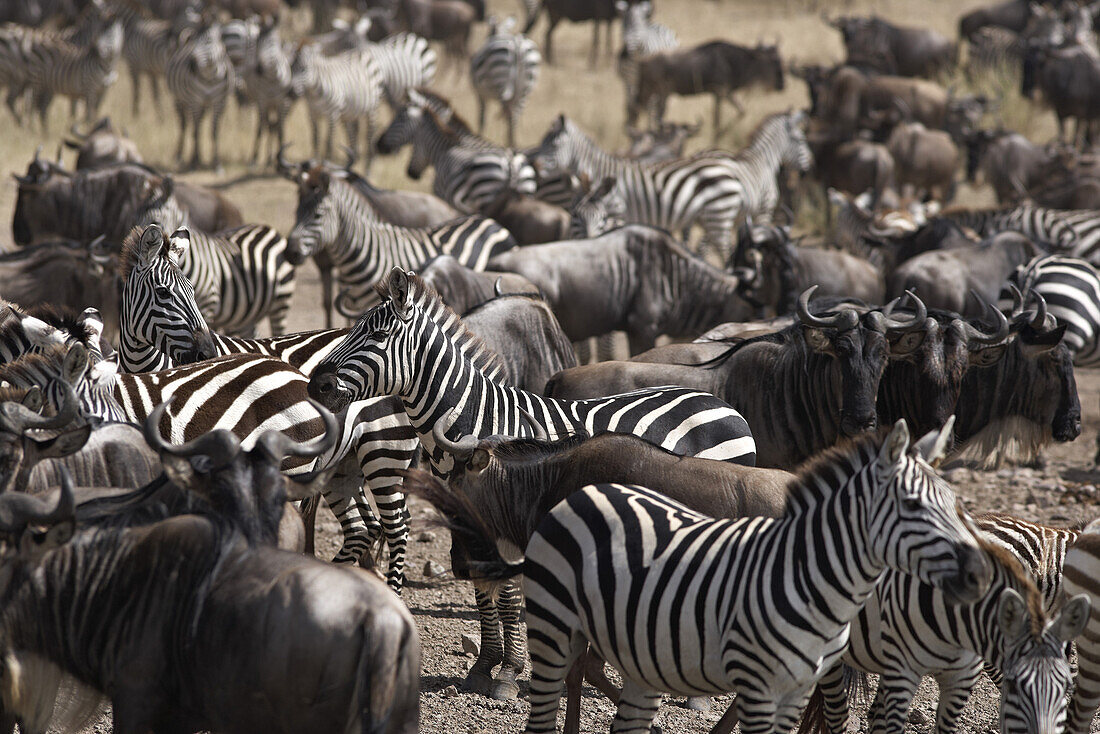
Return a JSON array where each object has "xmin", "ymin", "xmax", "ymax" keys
[{"xmin": 1020, "ymin": 45, "xmax": 1100, "ymax": 146}]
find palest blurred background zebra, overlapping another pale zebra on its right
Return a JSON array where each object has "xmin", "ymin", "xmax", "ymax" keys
[{"xmin": 290, "ymin": 44, "xmax": 384, "ymax": 165}]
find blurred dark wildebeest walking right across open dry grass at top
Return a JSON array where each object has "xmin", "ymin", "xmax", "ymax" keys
[{"xmin": 627, "ymin": 41, "xmax": 784, "ymax": 139}]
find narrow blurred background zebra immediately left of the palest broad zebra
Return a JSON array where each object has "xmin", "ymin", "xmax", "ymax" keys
[{"xmin": 221, "ymin": 18, "xmax": 294, "ymax": 165}]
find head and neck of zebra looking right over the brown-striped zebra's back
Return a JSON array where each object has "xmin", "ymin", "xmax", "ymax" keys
[{"xmin": 120, "ymin": 224, "xmax": 216, "ymax": 371}]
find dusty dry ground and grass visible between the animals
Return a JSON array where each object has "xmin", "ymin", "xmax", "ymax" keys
[{"xmin": 0, "ymin": 0, "xmax": 1100, "ymax": 734}]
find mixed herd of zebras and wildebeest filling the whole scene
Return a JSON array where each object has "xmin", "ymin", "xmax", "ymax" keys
[{"xmin": 0, "ymin": 0, "xmax": 1100, "ymax": 734}]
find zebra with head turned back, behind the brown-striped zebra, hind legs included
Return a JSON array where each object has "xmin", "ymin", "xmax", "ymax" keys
[{"xmin": 116, "ymin": 224, "xmax": 419, "ymax": 592}]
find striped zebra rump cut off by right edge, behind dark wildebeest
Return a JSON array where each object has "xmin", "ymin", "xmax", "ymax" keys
[{"xmin": 997, "ymin": 255, "xmax": 1100, "ymax": 366}]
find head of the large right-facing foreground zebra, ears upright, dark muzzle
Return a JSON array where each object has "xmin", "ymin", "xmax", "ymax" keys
[{"xmin": 861, "ymin": 417, "xmax": 992, "ymax": 604}]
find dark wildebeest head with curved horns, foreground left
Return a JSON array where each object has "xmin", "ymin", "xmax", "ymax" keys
[{"xmin": 143, "ymin": 398, "xmax": 339, "ymax": 545}]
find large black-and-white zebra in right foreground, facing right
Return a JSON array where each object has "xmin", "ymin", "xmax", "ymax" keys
[{"xmin": 422, "ymin": 421, "xmax": 990, "ymax": 732}]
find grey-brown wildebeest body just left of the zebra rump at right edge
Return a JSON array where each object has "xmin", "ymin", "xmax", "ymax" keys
[{"xmin": 887, "ymin": 232, "xmax": 1043, "ymax": 318}]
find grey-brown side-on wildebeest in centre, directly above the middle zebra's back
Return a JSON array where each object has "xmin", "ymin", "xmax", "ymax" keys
[{"xmin": 488, "ymin": 224, "xmax": 748, "ymax": 356}]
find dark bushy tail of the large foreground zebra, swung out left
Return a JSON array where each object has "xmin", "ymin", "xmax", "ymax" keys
[{"xmin": 402, "ymin": 469, "xmax": 524, "ymax": 581}]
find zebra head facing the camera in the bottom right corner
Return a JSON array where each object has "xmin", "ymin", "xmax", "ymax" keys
[{"xmin": 997, "ymin": 588, "xmax": 1091, "ymax": 734}]
